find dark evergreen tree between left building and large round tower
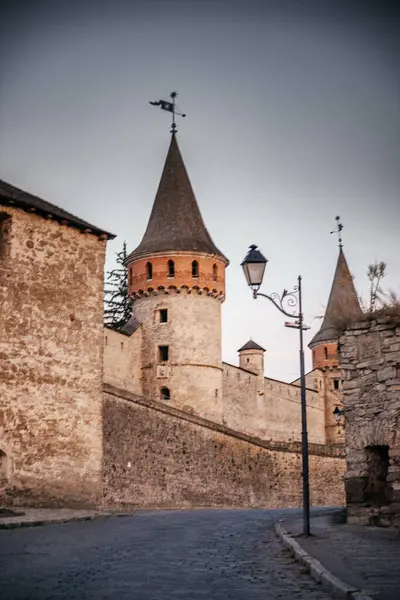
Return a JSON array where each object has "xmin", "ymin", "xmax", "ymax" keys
[{"xmin": 104, "ymin": 242, "xmax": 132, "ymax": 329}]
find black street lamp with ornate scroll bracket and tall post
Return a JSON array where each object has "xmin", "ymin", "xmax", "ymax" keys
[{"xmin": 241, "ymin": 244, "xmax": 310, "ymax": 537}]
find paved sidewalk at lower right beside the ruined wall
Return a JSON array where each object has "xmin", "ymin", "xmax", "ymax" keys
[{"xmin": 278, "ymin": 509, "xmax": 400, "ymax": 600}]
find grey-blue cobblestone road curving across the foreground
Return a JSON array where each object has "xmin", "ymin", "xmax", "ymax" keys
[{"xmin": 0, "ymin": 510, "xmax": 330, "ymax": 600}]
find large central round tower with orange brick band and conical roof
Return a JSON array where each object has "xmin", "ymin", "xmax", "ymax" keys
[{"xmin": 126, "ymin": 134, "xmax": 229, "ymax": 421}]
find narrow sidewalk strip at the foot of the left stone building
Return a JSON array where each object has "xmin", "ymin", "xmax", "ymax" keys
[{"xmin": 0, "ymin": 508, "xmax": 132, "ymax": 529}]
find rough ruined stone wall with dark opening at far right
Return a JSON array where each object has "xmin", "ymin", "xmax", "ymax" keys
[{"xmin": 340, "ymin": 318, "xmax": 400, "ymax": 526}]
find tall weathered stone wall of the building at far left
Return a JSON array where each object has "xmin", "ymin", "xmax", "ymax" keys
[{"xmin": 0, "ymin": 207, "xmax": 106, "ymax": 506}]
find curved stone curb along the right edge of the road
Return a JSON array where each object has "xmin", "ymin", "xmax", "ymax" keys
[{"xmin": 275, "ymin": 523, "xmax": 374, "ymax": 600}]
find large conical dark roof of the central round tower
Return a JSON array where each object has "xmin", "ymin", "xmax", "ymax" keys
[{"xmin": 127, "ymin": 134, "xmax": 228, "ymax": 262}]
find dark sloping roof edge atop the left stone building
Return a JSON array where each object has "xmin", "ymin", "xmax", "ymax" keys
[{"xmin": 0, "ymin": 179, "xmax": 115, "ymax": 240}]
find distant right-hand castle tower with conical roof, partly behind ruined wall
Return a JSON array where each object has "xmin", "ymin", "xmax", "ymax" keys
[{"xmin": 308, "ymin": 244, "xmax": 361, "ymax": 444}]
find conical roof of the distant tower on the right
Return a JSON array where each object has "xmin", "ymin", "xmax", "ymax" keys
[{"xmin": 309, "ymin": 249, "xmax": 361, "ymax": 348}]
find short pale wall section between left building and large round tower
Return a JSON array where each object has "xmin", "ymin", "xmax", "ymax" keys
[{"xmin": 103, "ymin": 327, "xmax": 142, "ymax": 396}]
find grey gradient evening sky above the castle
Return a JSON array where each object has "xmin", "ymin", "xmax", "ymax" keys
[{"xmin": 0, "ymin": 0, "xmax": 400, "ymax": 381}]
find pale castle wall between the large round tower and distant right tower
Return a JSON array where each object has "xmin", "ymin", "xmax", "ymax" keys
[{"xmin": 222, "ymin": 363, "xmax": 325, "ymax": 444}]
